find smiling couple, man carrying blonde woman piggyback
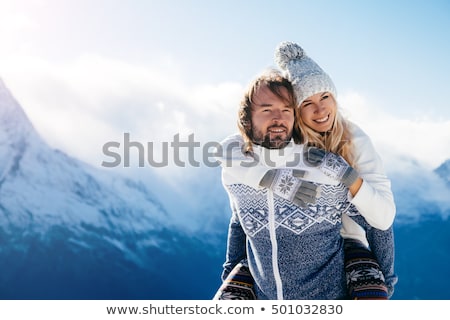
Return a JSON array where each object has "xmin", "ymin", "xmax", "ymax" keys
[{"xmin": 214, "ymin": 42, "xmax": 397, "ymax": 300}]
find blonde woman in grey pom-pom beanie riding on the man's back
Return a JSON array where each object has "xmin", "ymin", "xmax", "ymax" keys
[{"xmin": 275, "ymin": 42, "xmax": 397, "ymax": 298}]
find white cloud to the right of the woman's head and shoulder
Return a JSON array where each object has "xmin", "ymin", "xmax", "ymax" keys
[{"xmin": 339, "ymin": 92, "xmax": 450, "ymax": 172}]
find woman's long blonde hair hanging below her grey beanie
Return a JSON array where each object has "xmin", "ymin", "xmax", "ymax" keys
[{"xmin": 295, "ymin": 95, "xmax": 356, "ymax": 168}]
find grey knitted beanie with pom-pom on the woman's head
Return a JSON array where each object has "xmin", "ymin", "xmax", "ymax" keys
[{"xmin": 275, "ymin": 42, "xmax": 337, "ymax": 105}]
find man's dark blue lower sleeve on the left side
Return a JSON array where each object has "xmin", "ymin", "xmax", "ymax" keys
[{"xmin": 222, "ymin": 202, "xmax": 247, "ymax": 281}]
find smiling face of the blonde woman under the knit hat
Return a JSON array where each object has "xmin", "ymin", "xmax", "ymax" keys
[{"xmin": 300, "ymin": 92, "xmax": 337, "ymax": 132}]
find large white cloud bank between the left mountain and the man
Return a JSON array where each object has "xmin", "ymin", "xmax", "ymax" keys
[{"xmin": 0, "ymin": 55, "xmax": 243, "ymax": 232}]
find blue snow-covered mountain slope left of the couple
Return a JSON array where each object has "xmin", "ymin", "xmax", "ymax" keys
[{"xmin": 0, "ymin": 80, "xmax": 220, "ymax": 299}]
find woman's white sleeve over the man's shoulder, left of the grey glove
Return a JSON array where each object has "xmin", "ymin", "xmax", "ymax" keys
[{"xmin": 216, "ymin": 134, "xmax": 269, "ymax": 189}]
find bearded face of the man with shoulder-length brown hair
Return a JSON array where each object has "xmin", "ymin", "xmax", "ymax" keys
[{"xmin": 251, "ymin": 86, "xmax": 294, "ymax": 149}]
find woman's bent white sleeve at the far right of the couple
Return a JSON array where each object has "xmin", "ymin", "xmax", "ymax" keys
[{"xmin": 350, "ymin": 126, "xmax": 396, "ymax": 230}]
